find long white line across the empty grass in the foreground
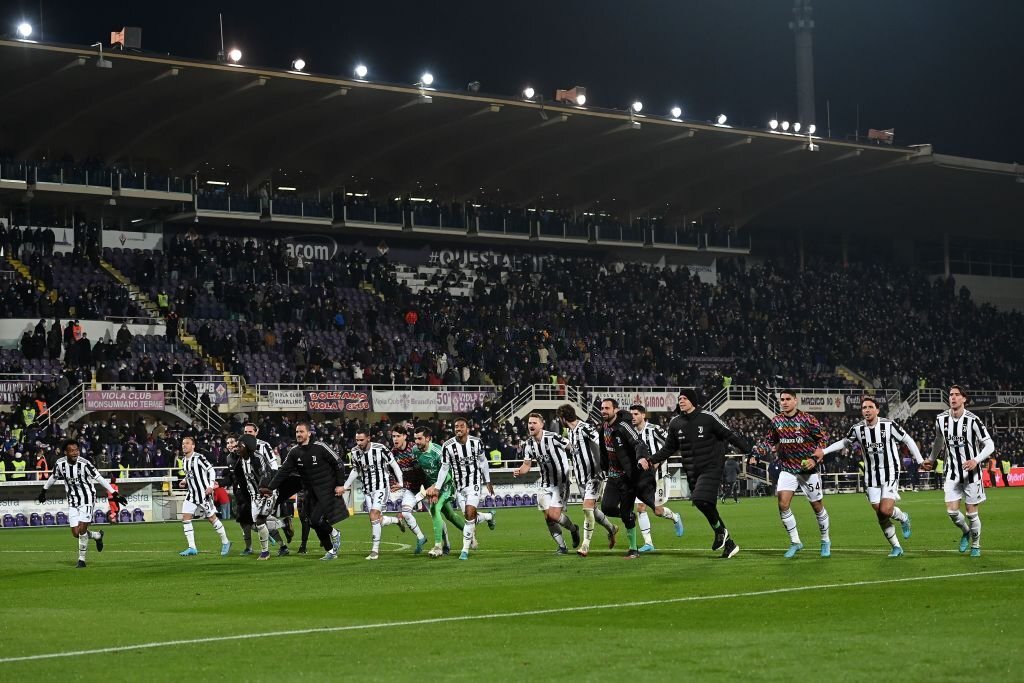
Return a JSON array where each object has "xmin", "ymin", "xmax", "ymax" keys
[{"xmin": 0, "ymin": 567, "xmax": 1024, "ymax": 664}]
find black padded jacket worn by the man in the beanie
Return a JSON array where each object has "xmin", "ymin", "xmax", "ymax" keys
[{"xmin": 651, "ymin": 408, "xmax": 751, "ymax": 479}]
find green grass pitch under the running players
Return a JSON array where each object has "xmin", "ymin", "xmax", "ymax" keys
[{"xmin": 0, "ymin": 489, "xmax": 1024, "ymax": 681}]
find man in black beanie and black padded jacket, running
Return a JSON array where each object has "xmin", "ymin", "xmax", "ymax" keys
[{"xmin": 639, "ymin": 389, "xmax": 751, "ymax": 558}]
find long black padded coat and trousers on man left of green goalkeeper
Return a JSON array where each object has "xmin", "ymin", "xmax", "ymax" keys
[{"xmin": 267, "ymin": 442, "xmax": 348, "ymax": 550}]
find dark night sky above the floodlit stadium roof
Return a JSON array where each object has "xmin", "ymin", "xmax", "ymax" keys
[{"xmin": 9, "ymin": 0, "xmax": 1024, "ymax": 163}]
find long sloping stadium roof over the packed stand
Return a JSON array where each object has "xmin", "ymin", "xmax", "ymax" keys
[{"xmin": 0, "ymin": 40, "xmax": 1024, "ymax": 234}]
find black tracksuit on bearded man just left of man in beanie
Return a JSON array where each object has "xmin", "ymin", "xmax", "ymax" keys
[{"xmin": 600, "ymin": 411, "xmax": 657, "ymax": 528}]
